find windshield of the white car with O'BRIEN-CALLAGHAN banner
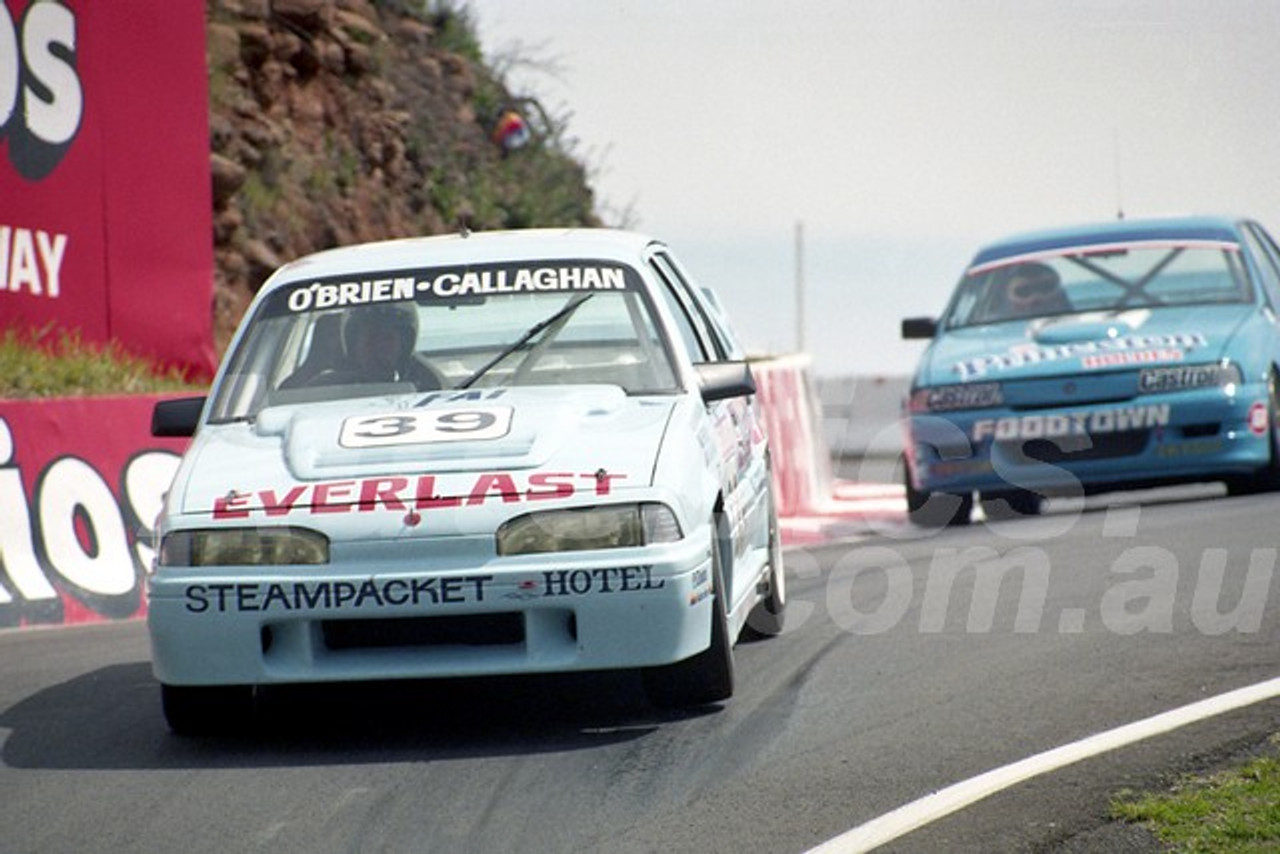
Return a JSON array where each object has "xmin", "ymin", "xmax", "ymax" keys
[{"xmin": 211, "ymin": 260, "xmax": 677, "ymax": 421}]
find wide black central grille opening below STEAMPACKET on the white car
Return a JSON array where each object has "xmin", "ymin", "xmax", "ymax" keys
[{"xmin": 320, "ymin": 612, "xmax": 525, "ymax": 650}]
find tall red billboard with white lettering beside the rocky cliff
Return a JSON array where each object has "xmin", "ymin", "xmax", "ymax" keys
[{"xmin": 0, "ymin": 0, "xmax": 215, "ymax": 375}]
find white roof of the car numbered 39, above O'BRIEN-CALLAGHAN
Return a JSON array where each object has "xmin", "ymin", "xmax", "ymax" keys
[{"xmin": 261, "ymin": 228, "xmax": 657, "ymax": 280}]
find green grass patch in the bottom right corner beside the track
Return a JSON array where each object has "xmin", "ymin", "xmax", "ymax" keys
[{"xmin": 1111, "ymin": 739, "xmax": 1280, "ymax": 854}]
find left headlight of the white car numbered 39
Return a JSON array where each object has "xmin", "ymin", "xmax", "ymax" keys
[{"xmin": 159, "ymin": 528, "xmax": 329, "ymax": 566}]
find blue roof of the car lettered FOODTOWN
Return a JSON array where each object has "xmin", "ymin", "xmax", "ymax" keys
[{"xmin": 970, "ymin": 216, "xmax": 1239, "ymax": 268}]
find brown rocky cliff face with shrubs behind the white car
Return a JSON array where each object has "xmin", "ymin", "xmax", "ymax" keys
[{"xmin": 206, "ymin": 0, "xmax": 599, "ymax": 352}]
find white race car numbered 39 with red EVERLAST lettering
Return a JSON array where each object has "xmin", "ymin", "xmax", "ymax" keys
[{"xmin": 147, "ymin": 229, "xmax": 786, "ymax": 734}]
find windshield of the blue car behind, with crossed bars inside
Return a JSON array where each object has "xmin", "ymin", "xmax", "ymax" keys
[{"xmin": 943, "ymin": 241, "xmax": 1253, "ymax": 329}]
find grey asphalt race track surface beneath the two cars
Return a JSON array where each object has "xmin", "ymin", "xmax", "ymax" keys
[{"xmin": 0, "ymin": 486, "xmax": 1280, "ymax": 854}]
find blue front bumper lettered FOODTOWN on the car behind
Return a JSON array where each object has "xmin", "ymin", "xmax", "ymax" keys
[{"xmin": 906, "ymin": 384, "xmax": 1274, "ymax": 494}]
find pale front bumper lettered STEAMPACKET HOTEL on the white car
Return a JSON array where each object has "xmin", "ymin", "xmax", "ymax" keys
[{"xmin": 147, "ymin": 535, "xmax": 713, "ymax": 685}]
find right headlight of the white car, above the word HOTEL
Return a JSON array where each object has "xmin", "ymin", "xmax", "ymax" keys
[{"xmin": 498, "ymin": 503, "xmax": 684, "ymax": 554}]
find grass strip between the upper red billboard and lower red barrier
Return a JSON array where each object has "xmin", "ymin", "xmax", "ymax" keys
[{"xmin": 0, "ymin": 329, "xmax": 206, "ymax": 399}]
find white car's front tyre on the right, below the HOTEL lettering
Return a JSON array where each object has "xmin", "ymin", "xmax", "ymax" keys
[{"xmin": 644, "ymin": 524, "xmax": 733, "ymax": 708}]
